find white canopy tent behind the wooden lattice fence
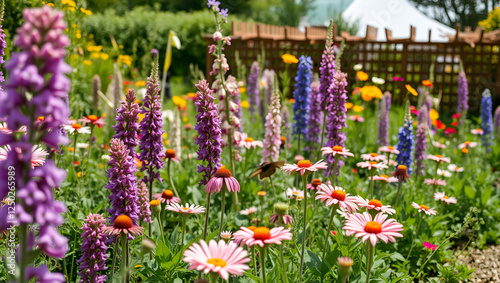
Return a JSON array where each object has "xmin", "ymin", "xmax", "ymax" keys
[{"xmin": 342, "ymin": 0, "xmax": 455, "ymax": 42}]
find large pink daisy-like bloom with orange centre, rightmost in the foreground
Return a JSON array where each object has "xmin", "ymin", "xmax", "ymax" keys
[{"xmin": 344, "ymin": 212, "xmax": 403, "ymax": 246}]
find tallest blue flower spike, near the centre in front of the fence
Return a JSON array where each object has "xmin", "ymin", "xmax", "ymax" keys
[{"xmin": 292, "ymin": 55, "xmax": 312, "ymax": 144}]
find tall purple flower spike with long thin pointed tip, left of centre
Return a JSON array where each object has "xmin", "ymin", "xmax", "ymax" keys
[{"xmin": 139, "ymin": 50, "xmax": 165, "ymax": 185}]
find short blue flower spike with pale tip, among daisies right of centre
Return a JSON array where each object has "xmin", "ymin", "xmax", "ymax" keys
[{"xmin": 396, "ymin": 107, "xmax": 415, "ymax": 175}]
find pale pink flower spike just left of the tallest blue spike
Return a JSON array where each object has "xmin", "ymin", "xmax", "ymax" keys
[{"xmin": 262, "ymin": 86, "xmax": 281, "ymax": 162}]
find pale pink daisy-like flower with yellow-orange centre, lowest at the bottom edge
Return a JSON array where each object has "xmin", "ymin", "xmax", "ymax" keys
[{"xmin": 183, "ymin": 240, "xmax": 250, "ymax": 280}]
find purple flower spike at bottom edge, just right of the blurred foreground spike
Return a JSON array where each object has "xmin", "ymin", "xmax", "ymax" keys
[{"xmin": 77, "ymin": 213, "xmax": 108, "ymax": 283}]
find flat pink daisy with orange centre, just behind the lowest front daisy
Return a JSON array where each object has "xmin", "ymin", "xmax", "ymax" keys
[{"xmin": 233, "ymin": 227, "xmax": 292, "ymax": 248}]
